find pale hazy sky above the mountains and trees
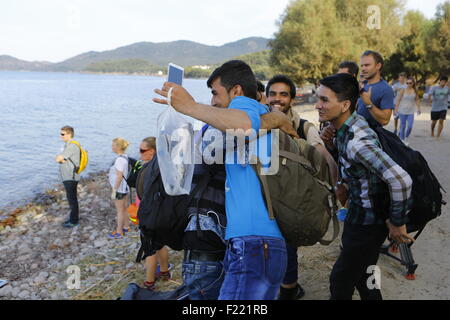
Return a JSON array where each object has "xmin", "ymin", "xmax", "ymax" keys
[{"xmin": 0, "ymin": 0, "xmax": 443, "ymax": 62}]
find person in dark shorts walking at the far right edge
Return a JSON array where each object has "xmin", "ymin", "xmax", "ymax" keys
[{"xmin": 428, "ymin": 76, "xmax": 450, "ymax": 139}]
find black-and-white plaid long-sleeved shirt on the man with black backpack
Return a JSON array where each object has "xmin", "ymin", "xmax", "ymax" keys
[{"xmin": 336, "ymin": 113, "xmax": 412, "ymax": 226}]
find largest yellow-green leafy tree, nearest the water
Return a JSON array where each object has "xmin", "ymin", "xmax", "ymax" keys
[{"xmin": 269, "ymin": 0, "xmax": 403, "ymax": 85}]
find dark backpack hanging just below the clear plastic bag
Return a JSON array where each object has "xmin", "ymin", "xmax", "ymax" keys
[{"xmin": 136, "ymin": 157, "xmax": 211, "ymax": 262}]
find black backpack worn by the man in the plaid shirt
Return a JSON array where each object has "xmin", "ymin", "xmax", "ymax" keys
[{"xmin": 369, "ymin": 121, "xmax": 446, "ymax": 228}]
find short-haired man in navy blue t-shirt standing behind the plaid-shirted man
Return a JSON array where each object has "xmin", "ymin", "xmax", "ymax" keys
[{"xmin": 357, "ymin": 51, "xmax": 395, "ymax": 126}]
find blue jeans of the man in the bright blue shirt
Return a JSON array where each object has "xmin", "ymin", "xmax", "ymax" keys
[{"xmin": 219, "ymin": 236, "xmax": 287, "ymax": 300}]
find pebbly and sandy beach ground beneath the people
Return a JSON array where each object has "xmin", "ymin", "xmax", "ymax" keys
[{"xmin": 0, "ymin": 106, "xmax": 450, "ymax": 300}]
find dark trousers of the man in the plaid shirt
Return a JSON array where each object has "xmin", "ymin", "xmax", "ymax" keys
[{"xmin": 330, "ymin": 223, "xmax": 388, "ymax": 300}]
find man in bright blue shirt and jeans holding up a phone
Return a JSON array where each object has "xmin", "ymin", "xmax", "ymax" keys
[{"xmin": 153, "ymin": 60, "xmax": 287, "ymax": 300}]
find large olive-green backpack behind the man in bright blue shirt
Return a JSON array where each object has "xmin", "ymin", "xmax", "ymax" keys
[{"xmin": 252, "ymin": 131, "xmax": 339, "ymax": 247}]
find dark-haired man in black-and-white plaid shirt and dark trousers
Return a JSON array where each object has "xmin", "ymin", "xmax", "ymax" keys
[{"xmin": 316, "ymin": 74, "xmax": 414, "ymax": 300}]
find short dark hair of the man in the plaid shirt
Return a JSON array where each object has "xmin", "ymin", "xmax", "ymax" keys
[{"xmin": 319, "ymin": 73, "xmax": 359, "ymax": 113}]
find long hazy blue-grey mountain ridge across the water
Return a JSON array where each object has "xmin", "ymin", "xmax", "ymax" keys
[{"xmin": 43, "ymin": 37, "xmax": 268, "ymax": 71}]
